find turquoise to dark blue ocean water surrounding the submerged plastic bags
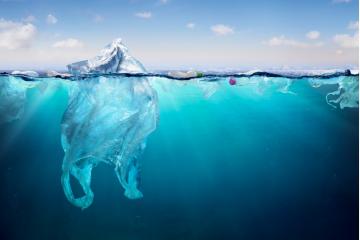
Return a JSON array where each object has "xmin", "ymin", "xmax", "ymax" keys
[{"xmin": 0, "ymin": 73, "xmax": 359, "ymax": 240}]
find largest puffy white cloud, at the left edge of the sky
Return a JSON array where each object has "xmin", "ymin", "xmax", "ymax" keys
[{"xmin": 0, "ymin": 18, "xmax": 37, "ymax": 50}]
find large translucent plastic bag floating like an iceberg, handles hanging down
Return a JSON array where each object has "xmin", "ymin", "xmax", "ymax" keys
[{"xmin": 61, "ymin": 37, "xmax": 158, "ymax": 208}]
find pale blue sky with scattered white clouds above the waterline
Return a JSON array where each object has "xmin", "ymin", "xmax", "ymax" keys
[{"xmin": 0, "ymin": 0, "xmax": 359, "ymax": 70}]
